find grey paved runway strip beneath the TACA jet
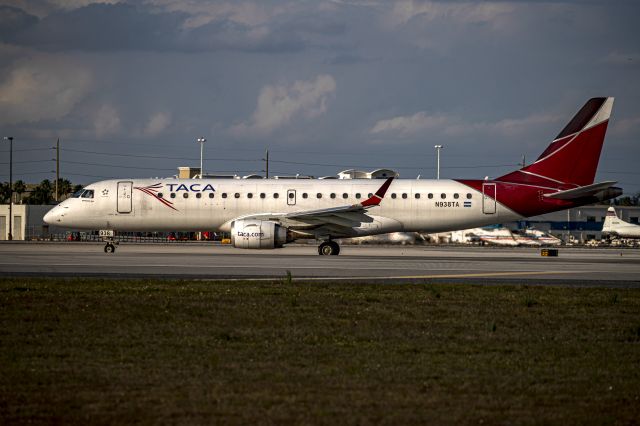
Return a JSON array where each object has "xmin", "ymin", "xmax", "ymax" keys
[{"xmin": 0, "ymin": 242, "xmax": 640, "ymax": 287}]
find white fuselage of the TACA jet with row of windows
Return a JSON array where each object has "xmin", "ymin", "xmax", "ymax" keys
[{"xmin": 45, "ymin": 179, "xmax": 521, "ymax": 236}]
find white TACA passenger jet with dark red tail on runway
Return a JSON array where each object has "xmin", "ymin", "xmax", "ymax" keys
[{"xmin": 44, "ymin": 97, "xmax": 622, "ymax": 255}]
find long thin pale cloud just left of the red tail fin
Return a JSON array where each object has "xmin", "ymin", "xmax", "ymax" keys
[{"xmin": 369, "ymin": 111, "xmax": 561, "ymax": 139}]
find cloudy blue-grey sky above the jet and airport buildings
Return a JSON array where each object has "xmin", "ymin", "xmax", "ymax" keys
[{"xmin": 0, "ymin": 0, "xmax": 640, "ymax": 194}]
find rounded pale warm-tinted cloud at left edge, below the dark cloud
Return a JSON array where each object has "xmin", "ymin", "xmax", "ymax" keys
[{"xmin": 0, "ymin": 56, "xmax": 92, "ymax": 124}]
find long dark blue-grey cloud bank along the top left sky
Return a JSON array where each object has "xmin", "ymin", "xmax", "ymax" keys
[{"xmin": 0, "ymin": 3, "xmax": 345, "ymax": 52}]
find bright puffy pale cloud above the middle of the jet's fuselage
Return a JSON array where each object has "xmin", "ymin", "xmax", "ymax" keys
[{"xmin": 231, "ymin": 74, "xmax": 336, "ymax": 136}]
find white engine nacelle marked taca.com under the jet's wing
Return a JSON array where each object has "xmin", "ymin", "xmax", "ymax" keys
[{"xmin": 231, "ymin": 219, "xmax": 288, "ymax": 249}]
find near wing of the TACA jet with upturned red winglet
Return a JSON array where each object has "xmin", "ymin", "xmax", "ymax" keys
[{"xmin": 235, "ymin": 177, "xmax": 394, "ymax": 236}]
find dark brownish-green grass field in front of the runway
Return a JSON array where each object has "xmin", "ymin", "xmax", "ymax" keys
[{"xmin": 0, "ymin": 278, "xmax": 640, "ymax": 424}]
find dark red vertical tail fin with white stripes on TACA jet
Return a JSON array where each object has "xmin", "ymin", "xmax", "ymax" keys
[{"xmin": 496, "ymin": 98, "xmax": 613, "ymax": 189}]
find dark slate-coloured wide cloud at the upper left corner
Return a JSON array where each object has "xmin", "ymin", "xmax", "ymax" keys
[{"xmin": 0, "ymin": 0, "xmax": 344, "ymax": 52}]
